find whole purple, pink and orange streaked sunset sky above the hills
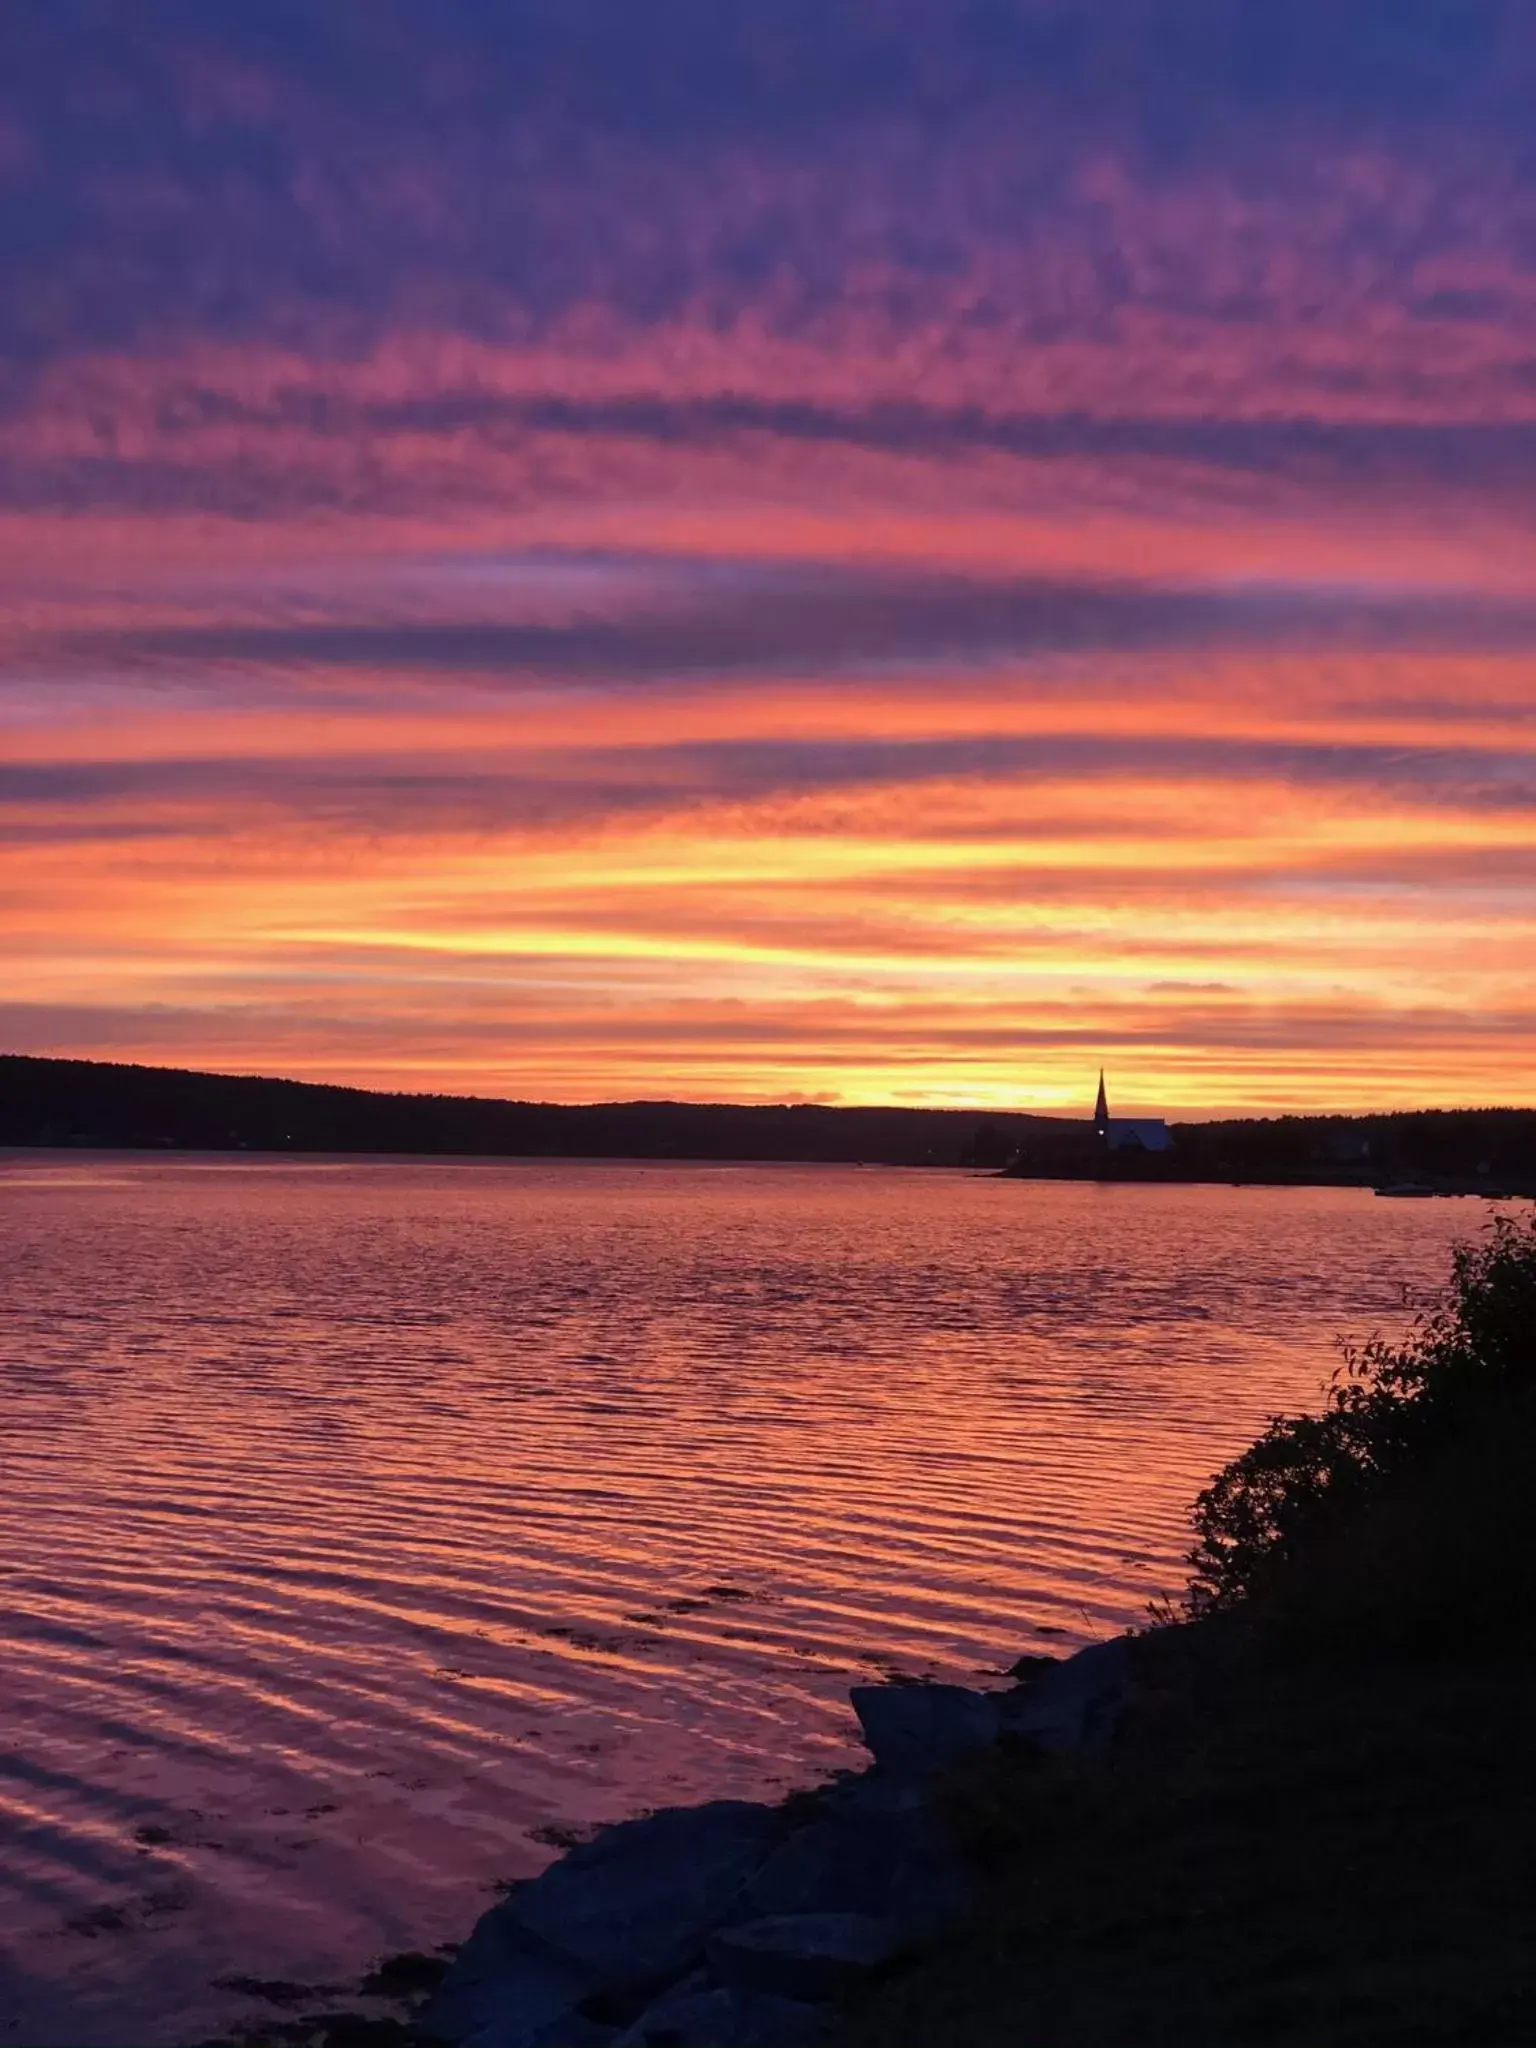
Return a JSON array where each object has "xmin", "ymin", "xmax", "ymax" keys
[{"xmin": 0, "ymin": 0, "xmax": 1536, "ymax": 1114}]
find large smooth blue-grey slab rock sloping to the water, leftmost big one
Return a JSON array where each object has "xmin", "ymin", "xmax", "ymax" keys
[{"xmin": 496, "ymin": 1800, "xmax": 784, "ymax": 1989}]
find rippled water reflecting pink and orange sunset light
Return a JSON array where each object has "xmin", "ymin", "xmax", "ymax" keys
[{"xmin": 0, "ymin": 1155, "xmax": 1485, "ymax": 2048}]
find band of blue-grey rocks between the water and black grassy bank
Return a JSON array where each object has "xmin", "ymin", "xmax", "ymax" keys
[{"xmin": 416, "ymin": 1636, "xmax": 1133, "ymax": 2048}]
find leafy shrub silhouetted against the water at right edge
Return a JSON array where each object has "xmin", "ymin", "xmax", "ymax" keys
[{"xmin": 1184, "ymin": 1214, "xmax": 1536, "ymax": 1634}]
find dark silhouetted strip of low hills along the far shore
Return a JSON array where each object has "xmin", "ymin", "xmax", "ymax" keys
[{"xmin": 0, "ymin": 1053, "xmax": 1536, "ymax": 1196}]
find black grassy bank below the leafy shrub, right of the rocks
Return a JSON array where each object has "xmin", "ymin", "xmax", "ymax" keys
[{"xmin": 838, "ymin": 1624, "xmax": 1536, "ymax": 2048}]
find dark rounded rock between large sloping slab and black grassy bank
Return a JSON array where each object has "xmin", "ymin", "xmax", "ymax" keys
[{"xmin": 743, "ymin": 1804, "xmax": 973, "ymax": 1937}]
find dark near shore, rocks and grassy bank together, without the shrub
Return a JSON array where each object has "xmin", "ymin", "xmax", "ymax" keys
[{"xmin": 183, "ymin": 1540, "xmax": 1536, "ymax": 2048}]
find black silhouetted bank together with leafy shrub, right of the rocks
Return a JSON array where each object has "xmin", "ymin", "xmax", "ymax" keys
[{"xmin": 838, "ymin": 1225, "xmax": 1536, "ymax": 2048}]
